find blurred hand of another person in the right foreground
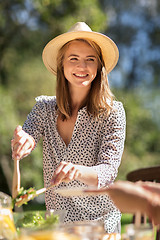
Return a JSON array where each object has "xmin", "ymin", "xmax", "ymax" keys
[{"xmin": 107, "ymin": 180, "xmax": 160, "ymax": 225}]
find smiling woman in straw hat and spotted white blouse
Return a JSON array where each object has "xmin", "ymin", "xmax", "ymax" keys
[{"xmin": 12, "ymin": 22, "xmax": 125, "ymax": 233}]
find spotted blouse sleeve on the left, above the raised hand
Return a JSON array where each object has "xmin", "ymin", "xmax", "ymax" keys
[{"xmin": 23, "ymin": 98, "xmax": 46, "ymax": 144}]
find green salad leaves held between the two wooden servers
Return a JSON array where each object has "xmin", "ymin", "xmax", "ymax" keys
[{"xmin": 13, "ymin": 187, "xmax": 37, "ymax": 207}]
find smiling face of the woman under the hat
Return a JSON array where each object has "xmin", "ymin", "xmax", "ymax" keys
[{"xmin": 63, "ymin": 40, "xmax": 98, "ymax": 88}]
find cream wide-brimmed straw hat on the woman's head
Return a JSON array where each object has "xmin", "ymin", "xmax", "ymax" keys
[{"xmin": 42, "ymin": 22, "xmax": 119, "ymax": 75}]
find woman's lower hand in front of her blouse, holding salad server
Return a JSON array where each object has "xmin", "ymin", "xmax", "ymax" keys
[{"xmin": 51, "ymin": 161, "xmax": 81, "ymax": 185}]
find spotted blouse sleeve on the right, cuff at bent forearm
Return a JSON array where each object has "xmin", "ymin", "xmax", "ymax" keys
[{"xmin": 93, "ymin": 102, "xmax": 126, "ymax": 188}]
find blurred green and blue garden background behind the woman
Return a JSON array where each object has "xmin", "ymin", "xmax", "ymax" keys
[{"xmin": 0, "ymin": 0, "xmax": 160, "ymax": 210}]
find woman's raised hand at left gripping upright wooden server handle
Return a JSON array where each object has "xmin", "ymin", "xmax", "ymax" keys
[{"xmin": 11, "ymin": 126, "xmax": 35, "ymax": 160}]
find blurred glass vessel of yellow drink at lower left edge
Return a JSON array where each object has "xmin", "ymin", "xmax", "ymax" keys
[{"xmin": 0, "ymin": 192, "xmax": 17, "ymax": 240}]
